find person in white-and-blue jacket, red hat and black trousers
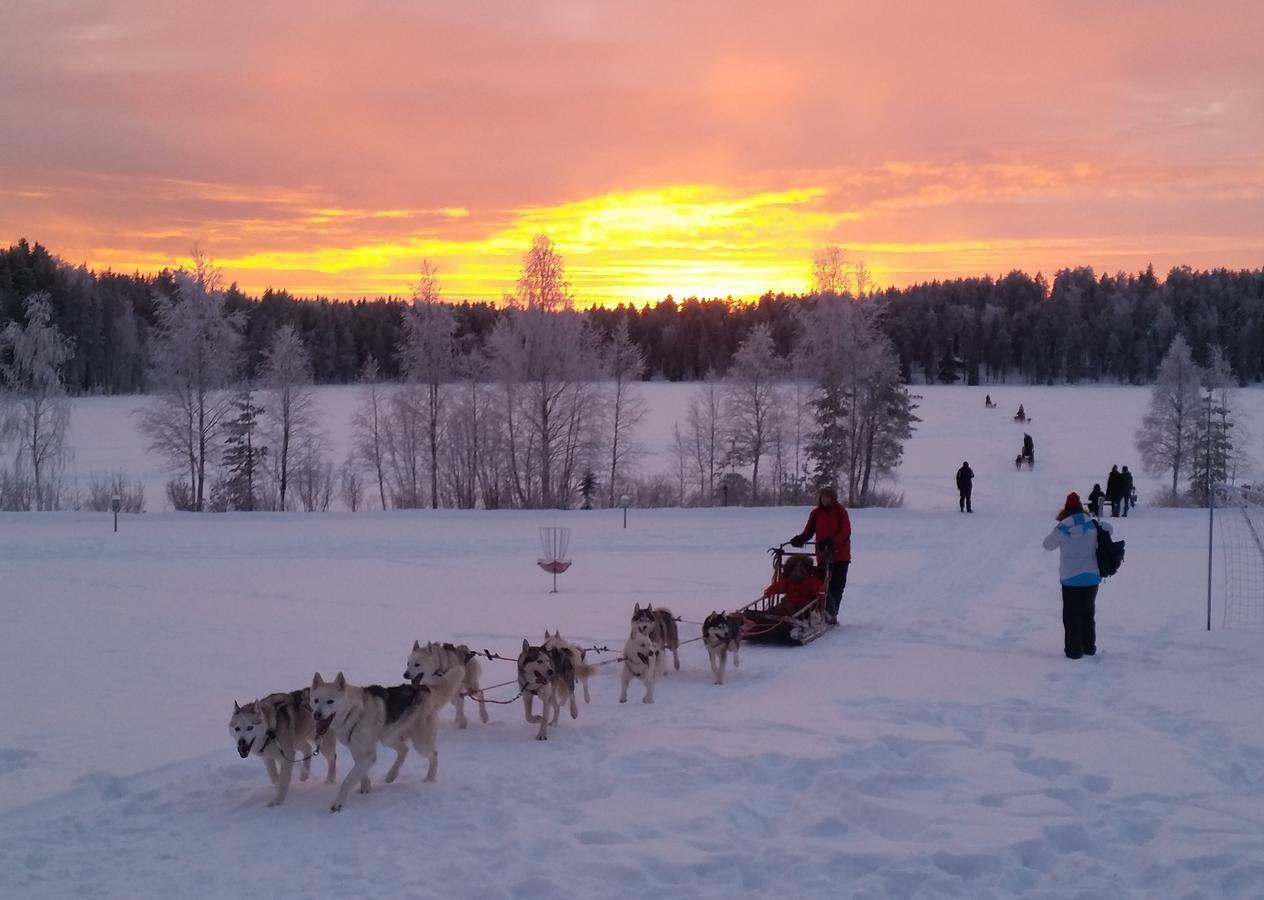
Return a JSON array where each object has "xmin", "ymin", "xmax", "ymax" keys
[{"xmin": 1044, "ymin": 492, "xmax": 1111, "ymax": 660}]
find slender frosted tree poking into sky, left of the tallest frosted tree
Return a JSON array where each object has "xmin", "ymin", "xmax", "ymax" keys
[{"xmin": 399, "ymin": 259, "xmax": 458, "ymax": 509}]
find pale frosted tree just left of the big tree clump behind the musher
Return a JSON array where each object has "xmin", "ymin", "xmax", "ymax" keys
[{"xmin": 724, "ymin": 322, "xmax": 786, "ymax": 506}]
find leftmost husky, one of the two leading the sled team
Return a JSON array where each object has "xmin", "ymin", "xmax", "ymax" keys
[{"xmin": 229, "ymin": 689, "xmax": 337, "ymax": 806}]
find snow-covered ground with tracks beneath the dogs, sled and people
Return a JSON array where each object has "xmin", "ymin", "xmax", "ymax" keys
[{"xmin": 0, "ymin": 386, "xmax": 1264, "ymax": 899}]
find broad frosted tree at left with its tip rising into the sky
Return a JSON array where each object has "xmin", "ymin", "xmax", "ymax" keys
[{"xmin": 140, "ymin": 257, "xmax": 241, "ymax": 512}]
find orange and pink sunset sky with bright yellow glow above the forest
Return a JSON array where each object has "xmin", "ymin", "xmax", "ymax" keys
[{"xmin": 0, "ymin": 0, "xmax": 1264, "ymax": 302}]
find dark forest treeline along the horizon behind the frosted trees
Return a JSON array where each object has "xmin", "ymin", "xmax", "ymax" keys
[{"xmin": 0, "ymin": 241, "xmax": 1264, "ymax": 393}]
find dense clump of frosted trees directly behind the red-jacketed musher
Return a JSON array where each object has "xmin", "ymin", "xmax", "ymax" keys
[{"xmin": 800, "ymin": 298, "xmax": 918, "ymax": 506}]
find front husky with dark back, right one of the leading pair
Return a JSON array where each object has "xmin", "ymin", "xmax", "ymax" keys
[{"xmin": 310, "ymin": 672, "xmax": 439, "ymax": 813}]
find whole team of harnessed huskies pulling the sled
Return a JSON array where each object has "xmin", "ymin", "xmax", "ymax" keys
[{"xmin": 229, "ymin": 604, "xmax": 742, "ymax": 813}]
